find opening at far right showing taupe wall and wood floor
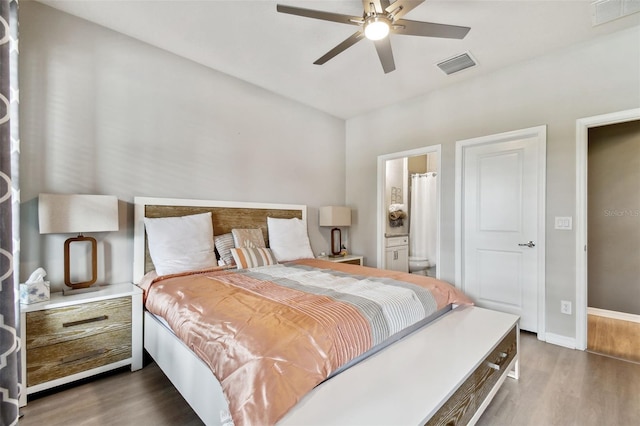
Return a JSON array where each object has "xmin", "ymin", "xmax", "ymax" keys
[{"xmin": 587, "ymin": 120, "xmax": 640, "ymax": 362}]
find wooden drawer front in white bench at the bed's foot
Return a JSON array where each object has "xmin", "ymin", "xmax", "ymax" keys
[{"xmin": 427, "ymin": 326, "xmax": 518, "ymax": 426}]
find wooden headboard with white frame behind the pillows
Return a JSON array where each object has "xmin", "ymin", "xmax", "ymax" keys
[{"xmin": 133, "ymin": 197, "xmax": 307, "ymax": 284}]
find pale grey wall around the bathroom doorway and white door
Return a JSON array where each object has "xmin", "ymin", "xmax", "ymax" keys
[{"xmin": 346, "ymin": 27, "xmax": 640, "ymax": 337}]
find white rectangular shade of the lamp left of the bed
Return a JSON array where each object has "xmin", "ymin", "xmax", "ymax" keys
[{"xmin": 38, "ymin": 194, "xmax": 118, "ymax": 234}]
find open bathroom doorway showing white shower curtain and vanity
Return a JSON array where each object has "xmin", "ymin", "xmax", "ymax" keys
[{"xmin": 377, "ymin": 145, "xmax": 441, "ymax": 278}]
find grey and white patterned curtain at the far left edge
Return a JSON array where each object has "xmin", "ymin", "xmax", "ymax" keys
[{"xmin": 0, "ymin": 0, "xmax": 20, "ymax": 426}]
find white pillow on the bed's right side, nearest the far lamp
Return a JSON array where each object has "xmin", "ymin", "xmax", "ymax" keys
[{"xmin": 267, "ymin": 217, "xmax": 314, "ymax": 262}]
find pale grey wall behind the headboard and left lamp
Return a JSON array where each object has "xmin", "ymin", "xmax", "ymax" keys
[{"xmin": 19, "ymin": 2, "xmax": 345, "ymax": 289}]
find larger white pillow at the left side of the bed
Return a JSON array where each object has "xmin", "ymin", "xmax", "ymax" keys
[{"xmin": 144, "ymin": 212, "xmax": 217, "ymax": 275}]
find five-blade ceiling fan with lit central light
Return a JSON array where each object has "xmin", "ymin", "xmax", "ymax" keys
[{"xmin": 276, "ymin": 0, "xmax": 471, "ymax": 74}]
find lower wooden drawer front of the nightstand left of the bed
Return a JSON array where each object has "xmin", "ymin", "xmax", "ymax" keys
[{"xmin": 27, "ymin": 328, "xmax": 131, "ymax": 386}]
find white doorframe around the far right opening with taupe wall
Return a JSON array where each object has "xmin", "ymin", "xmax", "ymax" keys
[{"xmin": 575, "ymin": 108, "xmax": 640, "ymax": 351}]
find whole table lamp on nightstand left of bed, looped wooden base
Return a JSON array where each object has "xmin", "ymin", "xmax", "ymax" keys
[{"xmin": 38, "ymin": 194, "xmax": 118, "ymax": 290}]
